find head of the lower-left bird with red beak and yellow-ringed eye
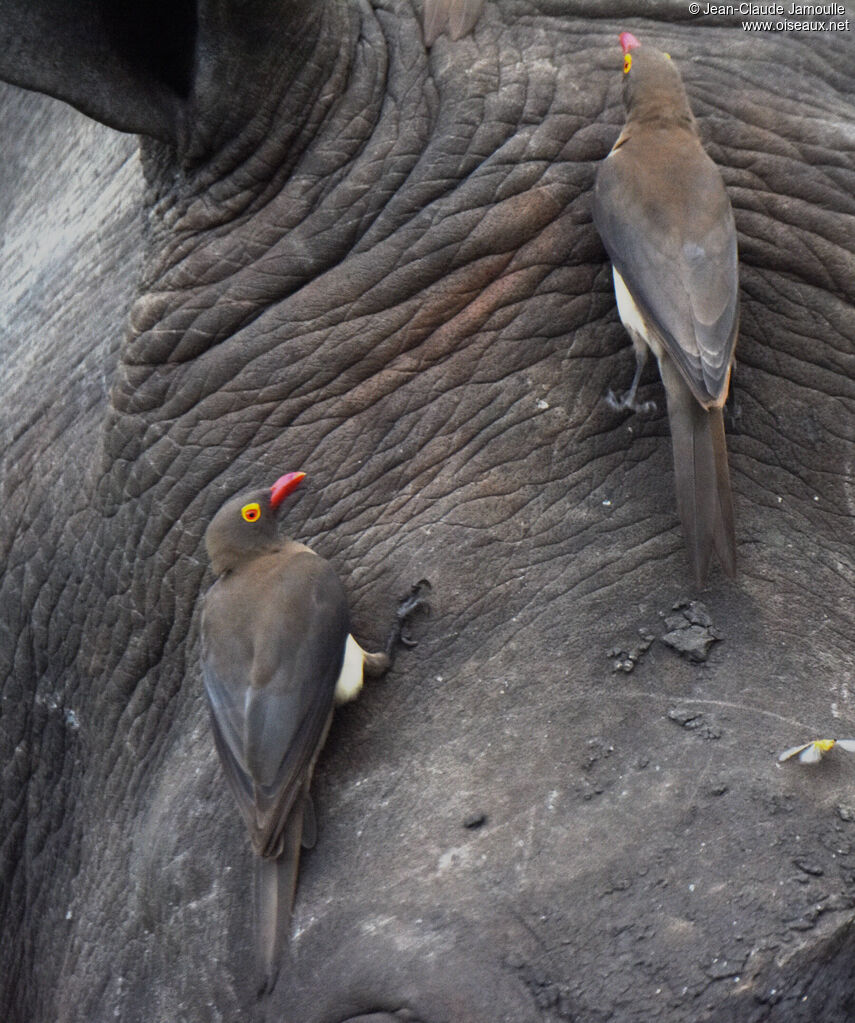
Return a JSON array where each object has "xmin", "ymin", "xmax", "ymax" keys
[{"xmin": 205, "ymin": 473, "xmax": 306, "ymax": 575}]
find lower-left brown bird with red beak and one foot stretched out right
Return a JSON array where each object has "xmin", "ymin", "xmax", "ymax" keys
[{"xmin": 201, "ymin": 473, "xmax": 428, "ymax": 989}]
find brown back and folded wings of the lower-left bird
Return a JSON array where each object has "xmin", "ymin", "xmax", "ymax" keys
[{"xmin": 203, "ymin": 550, "xmax": 350, "ymax": 856}]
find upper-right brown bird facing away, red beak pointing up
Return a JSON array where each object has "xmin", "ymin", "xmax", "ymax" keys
[{"xmin": 593, "ymin": 32, "xmax": 739, "ymax": 585}]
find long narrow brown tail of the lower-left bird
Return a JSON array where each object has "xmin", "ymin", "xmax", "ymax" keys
[{"xmin": 256, "ymin": 800, "xmax": 303, "ymax": 992}]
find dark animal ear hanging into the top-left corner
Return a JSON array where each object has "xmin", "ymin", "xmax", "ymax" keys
[{"xmin": 0, "ymin": 0, "xmax": 317, "ymax": 158}]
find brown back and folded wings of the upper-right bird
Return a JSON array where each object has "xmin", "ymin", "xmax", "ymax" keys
[{"xmin": 593, "ymin": 129, "xmax": 739, "ymax": 406}]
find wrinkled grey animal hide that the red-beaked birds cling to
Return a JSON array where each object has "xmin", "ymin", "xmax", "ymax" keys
[{"xmin": 0, "ymin": 0, "xmax": 855, "ymax": 1023}]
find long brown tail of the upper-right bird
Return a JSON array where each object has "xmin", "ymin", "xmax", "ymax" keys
[{"xmin": 660, "ymin": 359, "xmax": 736, "ymax": 586}]
